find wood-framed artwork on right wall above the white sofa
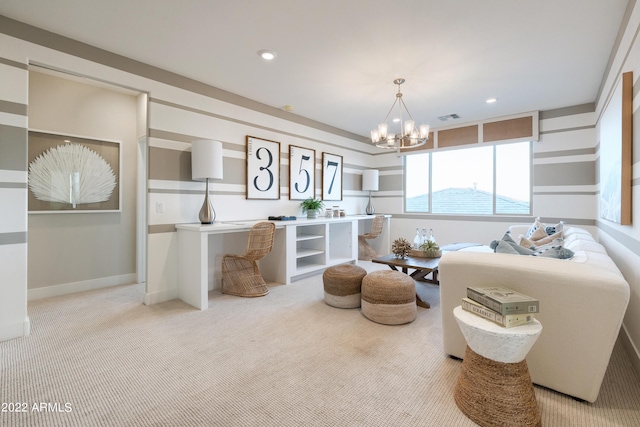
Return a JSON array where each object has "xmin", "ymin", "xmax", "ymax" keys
[{"xmin": 599, "ymin": 72, "xmax": 633, "ymax": 225}]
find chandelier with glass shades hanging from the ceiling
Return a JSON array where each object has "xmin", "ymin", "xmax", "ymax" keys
[{"xmin": 371, "ymin": 79, "xmax": 429, "ymax": 150}]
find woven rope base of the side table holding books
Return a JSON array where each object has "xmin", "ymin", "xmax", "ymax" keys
[{"xmin": 454, "ymin": 346, "xmax": 542, "ymax": 427}]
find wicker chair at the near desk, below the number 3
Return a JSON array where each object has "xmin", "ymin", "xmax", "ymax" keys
[{"xmin": 222, "ymin": 222, "xmax": 276, "ymax": 297}]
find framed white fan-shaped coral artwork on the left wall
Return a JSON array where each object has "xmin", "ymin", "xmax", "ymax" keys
[{"xmin": 28, "ymin": 131, "xmax": 122, "ymax": 213}]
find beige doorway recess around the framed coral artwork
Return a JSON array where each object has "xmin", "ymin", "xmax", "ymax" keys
[{"xmin": 28, "ymin": 64, "xmax": 149, "ymax": 301}]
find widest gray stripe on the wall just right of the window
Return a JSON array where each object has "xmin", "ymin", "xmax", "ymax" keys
[{"xmin": 533, "ymin": 161, "xmax": 596, "ymax": 187}]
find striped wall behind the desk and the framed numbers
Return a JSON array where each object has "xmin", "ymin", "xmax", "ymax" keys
[{"xmin": 149, "ymin": 97, "xmax": 370, "ymax": 233}]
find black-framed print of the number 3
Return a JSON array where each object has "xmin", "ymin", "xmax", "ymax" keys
[{"xmin": 247, "ymin": 135, "xmax": 280, "ymax": 200}]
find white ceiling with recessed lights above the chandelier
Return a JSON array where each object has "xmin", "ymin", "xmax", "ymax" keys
[{"xmin": 0, "ymin": 0, "xmax": 627, "ymax": 136}]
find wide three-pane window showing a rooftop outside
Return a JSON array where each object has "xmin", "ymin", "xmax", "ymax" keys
[{"xmin": 405, "ymin": 142, "xmax": 531, "ymax": 215}]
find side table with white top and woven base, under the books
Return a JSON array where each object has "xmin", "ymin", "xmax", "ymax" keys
[{"xmin": 453, "ymin": 306, "xmax": 542, "ymax": 427}]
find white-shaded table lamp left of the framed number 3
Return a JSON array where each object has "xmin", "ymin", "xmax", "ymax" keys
[{"xmin": 191, "ymin": 139, "xmax": 222, "ymax": 224}]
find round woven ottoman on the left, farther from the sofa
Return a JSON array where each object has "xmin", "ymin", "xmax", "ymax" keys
[{"xmin": 322, "ymin": 264, "xmax": 367, "ymax": 308}]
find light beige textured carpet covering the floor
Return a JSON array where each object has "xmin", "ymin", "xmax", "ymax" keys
[{"xmin": 0, "ymin": 262, "xmax": 640, "ymax": 427}]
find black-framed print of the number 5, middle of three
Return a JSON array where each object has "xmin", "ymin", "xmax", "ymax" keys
[{"xmin": 289, "ymin": 145, "xmax": 316, "ymax": 200}]
